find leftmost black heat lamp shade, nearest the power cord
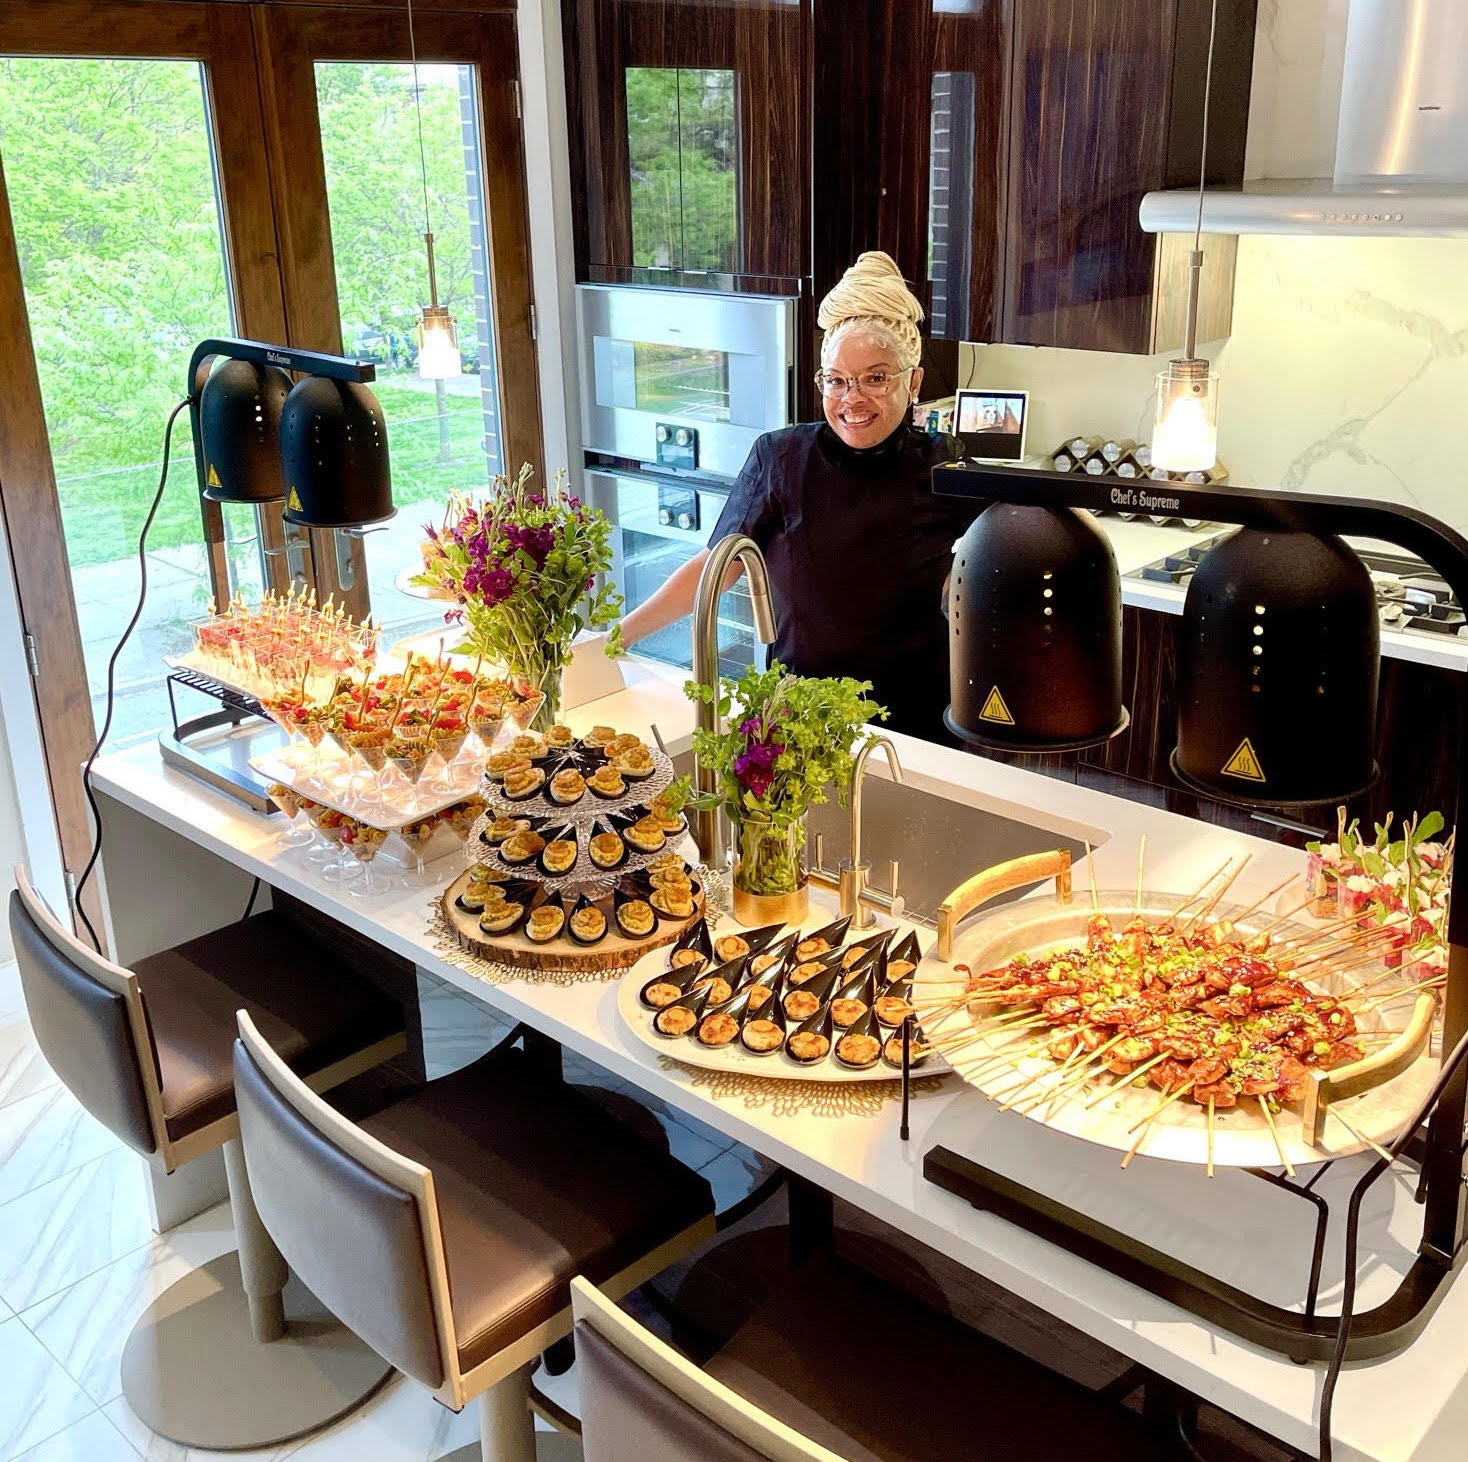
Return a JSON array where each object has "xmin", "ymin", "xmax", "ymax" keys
[{"xmin": 198, "ymin": 357, "xmax": 291, "ymax": 502}]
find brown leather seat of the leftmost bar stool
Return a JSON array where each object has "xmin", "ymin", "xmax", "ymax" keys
[{"xmin": 132, "ymin": 910, "xmax": 402, "ymax": 1142}]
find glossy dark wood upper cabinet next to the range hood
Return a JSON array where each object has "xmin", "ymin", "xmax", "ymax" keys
[{"xmin": 998, "ymin": 0, "xmax": 1255, "ymax": 352}]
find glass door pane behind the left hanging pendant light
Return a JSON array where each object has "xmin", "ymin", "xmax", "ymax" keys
[{"xmin": 316, "ymin": 62, "xmax": 504, "ymax": 644}]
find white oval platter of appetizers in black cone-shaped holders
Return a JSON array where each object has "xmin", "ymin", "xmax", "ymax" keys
[{"xmin": 617, "ymin": 912, "xmax": 948, "ymax": 1082}]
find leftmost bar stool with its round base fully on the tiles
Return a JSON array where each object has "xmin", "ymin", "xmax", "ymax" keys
[{"xmin": 10, "ymin": 869, "xmax": 407, "ymax": 1449}]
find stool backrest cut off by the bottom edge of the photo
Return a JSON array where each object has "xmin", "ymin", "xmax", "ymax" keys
[{"xmin": 571, "ymin": 1277, "xmax": 843, "ymax": 1462}]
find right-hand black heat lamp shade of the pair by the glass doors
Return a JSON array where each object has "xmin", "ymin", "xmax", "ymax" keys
[{"xmin": 280, "ymin": 376, "xmax": 396, "ymax": 528}]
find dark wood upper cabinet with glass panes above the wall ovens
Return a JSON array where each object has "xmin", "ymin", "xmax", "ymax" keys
[{"xmin": 562, "ymin": 0, "xmax": 810, "ymax": 291}]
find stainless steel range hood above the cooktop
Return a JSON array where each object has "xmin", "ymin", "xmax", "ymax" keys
[{"xmin": 1141, "ymin": 0, "xmax": 1468, "ymax": 238}]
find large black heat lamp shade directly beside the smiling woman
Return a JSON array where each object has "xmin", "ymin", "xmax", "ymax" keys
[{"xmin": 942, "ymin": 502, "xmax": 1127, "ymax": 753}]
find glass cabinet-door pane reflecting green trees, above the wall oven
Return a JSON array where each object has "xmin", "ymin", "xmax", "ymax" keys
[{"xmin": 627, "ymin": 66, "xmax": 740, "ymax": 273}]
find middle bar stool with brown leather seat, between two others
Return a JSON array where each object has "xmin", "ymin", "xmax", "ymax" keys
[{"xmin": 235, "ymin": 1011, "xmax": 713, "ymax": 1462}]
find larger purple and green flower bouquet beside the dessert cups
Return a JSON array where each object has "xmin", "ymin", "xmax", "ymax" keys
[{"xmin": 413, "ymin": 465, "xmax": 622, "ymax": 730}]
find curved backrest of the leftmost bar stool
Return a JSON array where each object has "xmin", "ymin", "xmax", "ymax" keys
[{"xmin": 10, "ymin": 868, "xmax": 166, "ymax": 1155}]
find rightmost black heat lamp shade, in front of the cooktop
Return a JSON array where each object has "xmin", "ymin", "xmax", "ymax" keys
[{"xmin": 1171, "ymin": 528, "xmax": 1380, "ymax": 807}]
